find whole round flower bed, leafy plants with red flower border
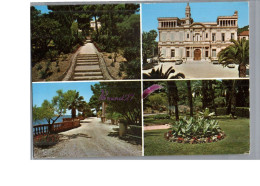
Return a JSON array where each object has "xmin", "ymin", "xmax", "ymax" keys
[{"xmin": 164, "ymin": 117, "xmax": 225, "ymax": 144}]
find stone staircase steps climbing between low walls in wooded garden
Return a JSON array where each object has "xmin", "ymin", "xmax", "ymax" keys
[{"xmin": 72, "ymin": 54, "xmax": 104, "ymax": 81}]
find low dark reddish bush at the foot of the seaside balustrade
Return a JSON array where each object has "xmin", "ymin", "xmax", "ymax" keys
[{"xmin": 33, "ymin": 134, "xmax": 59, "ymax": 148}]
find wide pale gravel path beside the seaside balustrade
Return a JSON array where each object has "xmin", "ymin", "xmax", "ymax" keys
[{"xmin": 34, "ymin": 118, "xmax": 142, "ymax": 159}]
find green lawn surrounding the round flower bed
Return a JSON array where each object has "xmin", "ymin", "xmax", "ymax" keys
[{"xmin": 144, "ymin": 118, "xmax": 249, "ymax": 156}]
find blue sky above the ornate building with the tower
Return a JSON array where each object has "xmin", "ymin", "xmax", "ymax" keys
[{"xmin": 142, "ymin": 2, "xmax": 249, "ymax": 40}]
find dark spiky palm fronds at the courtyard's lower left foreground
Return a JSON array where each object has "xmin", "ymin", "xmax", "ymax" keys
[{"xmin": 143, "ymin": 65, "xmax": 185, "ymax": 79}]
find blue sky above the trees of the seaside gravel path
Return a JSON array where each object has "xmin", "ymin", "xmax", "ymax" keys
[{"xmin": 32, "ymin": 82, "xmax": 97, "ymax": 114}]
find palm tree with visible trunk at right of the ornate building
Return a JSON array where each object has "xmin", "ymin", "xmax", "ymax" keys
[{"xmin": 218, "ymin": 39, "xmax": 249, "ymax": 77}]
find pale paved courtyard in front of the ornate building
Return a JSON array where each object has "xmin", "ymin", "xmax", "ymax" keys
[{"xmin": 143, "ymin": 61, "xmax": 242, "ymax": 79}]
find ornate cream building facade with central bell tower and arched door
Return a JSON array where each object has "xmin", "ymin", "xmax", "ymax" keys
[{"xmin": 158, "ymin": 3, "xmax": 238, "ymax": 61}]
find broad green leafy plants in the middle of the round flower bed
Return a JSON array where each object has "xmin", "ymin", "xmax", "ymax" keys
[{"xmin": 172, "ymin": 117, "xmax": 222, "ymax": 138}]
